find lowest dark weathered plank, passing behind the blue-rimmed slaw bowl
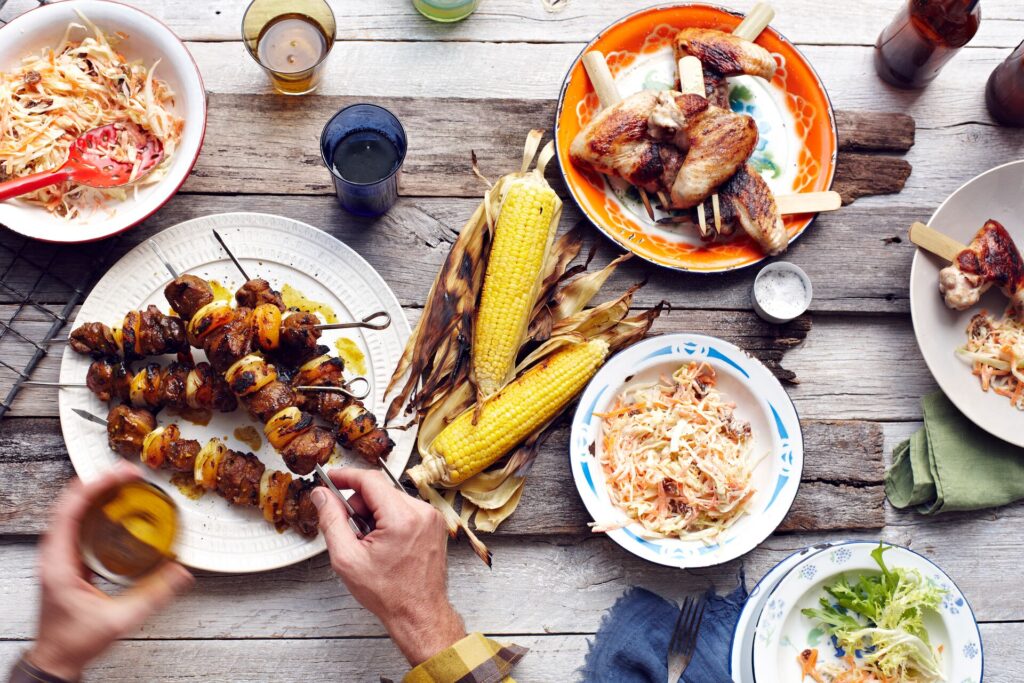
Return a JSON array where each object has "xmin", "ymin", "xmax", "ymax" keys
[{"xmin": 0, "ymin": 416, "xmax": 885, "ymax": 536}]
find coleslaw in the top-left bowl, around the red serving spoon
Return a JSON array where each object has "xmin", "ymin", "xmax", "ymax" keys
[{"xmin": 0, "ymin": 14, "xmax": 184, "ymax": 219}]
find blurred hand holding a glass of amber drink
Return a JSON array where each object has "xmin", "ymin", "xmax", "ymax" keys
[{"xmin": 26, "ymin": 463, "xmax": 194, "ymax": 680}]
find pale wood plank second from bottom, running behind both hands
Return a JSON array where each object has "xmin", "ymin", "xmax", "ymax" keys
[{"xmin": 0, "ymin": 505, "xmax": 1024, "ymax": 639}]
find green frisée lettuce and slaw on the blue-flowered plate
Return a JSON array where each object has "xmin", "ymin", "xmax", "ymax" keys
[{"xmin": 798, "ymin": 544, "xmax": 946, "ymax": 683}]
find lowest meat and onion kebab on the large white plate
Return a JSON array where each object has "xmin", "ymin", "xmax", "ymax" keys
[{"xmin": 99, "ymin": 405, "xmax": 317, "ymax": 538}]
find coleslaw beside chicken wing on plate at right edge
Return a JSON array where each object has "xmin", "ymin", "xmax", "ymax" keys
[{"xmin": 956, "ymin": 310, "xmax": 1024, "ymax": 411}]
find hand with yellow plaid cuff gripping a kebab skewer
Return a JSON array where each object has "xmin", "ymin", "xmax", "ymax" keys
[{"xmin": 312, "ymin": 468, "xmax": 466, "ymax": 667}]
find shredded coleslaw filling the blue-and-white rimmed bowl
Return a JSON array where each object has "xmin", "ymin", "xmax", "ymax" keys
[{"xmin": 594, "ymin": 362, "xmax": 757, "ymax": 542}]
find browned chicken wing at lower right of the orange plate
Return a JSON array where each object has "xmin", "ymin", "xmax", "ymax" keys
[{"xmin": 708, "ymin": 164, "xmax": 790, "ymax": 256}]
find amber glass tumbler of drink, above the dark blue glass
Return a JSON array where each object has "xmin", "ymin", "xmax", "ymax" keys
[{"xmin": 242, "ymin": 0, "xmax": 337, "ymax": 95}]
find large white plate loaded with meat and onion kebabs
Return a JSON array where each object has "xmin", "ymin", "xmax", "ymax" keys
[{"xmin": 59, "ymin": 213, "xmax": 415, "ymax": 572}]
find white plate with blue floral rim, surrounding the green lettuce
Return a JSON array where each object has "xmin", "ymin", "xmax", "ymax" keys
[{"xmin": 754, "ymin": 542, "xmax": 984, "ymax": 683}]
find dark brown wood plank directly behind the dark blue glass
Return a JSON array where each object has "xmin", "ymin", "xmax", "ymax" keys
[{"xmin": 183, "ymin": 94, "xmax": 912, "ymax": 199}]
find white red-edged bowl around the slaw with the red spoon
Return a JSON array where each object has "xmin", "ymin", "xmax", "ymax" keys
[{"xmin": 0, "ymin": 0, "xmax": 206, "ymax": 242}]
